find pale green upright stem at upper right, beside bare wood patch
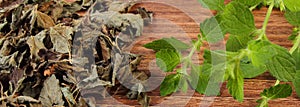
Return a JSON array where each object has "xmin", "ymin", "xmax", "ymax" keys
[{"xmin": 258, "ymin": 1, "xmax": 274, "ymax": 40}]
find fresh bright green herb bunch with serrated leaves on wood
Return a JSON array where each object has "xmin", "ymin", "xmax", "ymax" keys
[{"xmin": 144, "ymin": 0, "xmax": 300, "ymax": 107}]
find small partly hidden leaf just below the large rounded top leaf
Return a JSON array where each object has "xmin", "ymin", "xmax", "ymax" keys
[{"xmin": 226, "ymin": 35, "xmax": 252, "ymax": 52}]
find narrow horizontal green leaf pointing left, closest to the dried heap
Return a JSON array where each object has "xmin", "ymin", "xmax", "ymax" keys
[{"xmin": 144, "ymin": 37, "xmax": 190, "ymax": 51}]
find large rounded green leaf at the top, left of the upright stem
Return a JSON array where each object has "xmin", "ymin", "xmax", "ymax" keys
[{"xmin": 221, "ymin": 1, "xmax": 256, "ymax": 35}]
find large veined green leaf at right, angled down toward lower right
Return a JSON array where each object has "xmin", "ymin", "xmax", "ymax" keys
[{"xmin": 248, "ymin": 40, "xmax": 296, "ymax": 81}]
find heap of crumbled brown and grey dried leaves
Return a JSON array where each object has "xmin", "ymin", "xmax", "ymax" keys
[{"xmin": 0, "ymin": 0, "xmax": 151, "ymax": 107}]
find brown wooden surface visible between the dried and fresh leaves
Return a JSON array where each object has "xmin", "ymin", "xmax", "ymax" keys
[{"xmin": 97, "ymin": 0, "xmax": 300, "ymax": 107}]
